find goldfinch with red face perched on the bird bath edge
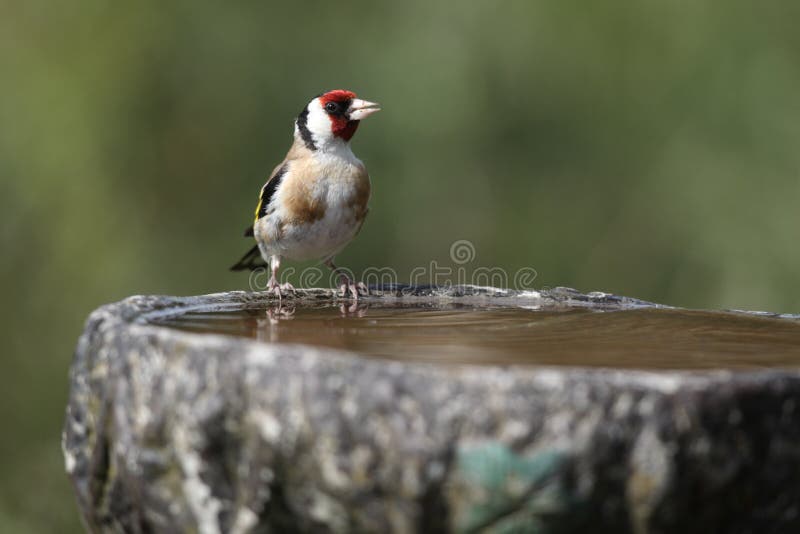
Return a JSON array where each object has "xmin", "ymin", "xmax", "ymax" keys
[{"xmin": 231, "ymin": 89, "xmax": 381, "ymax": 301}]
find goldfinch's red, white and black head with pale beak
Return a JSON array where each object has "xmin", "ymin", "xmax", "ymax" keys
[{"xmin": 294, "ymin": 89, "xmax": 381, "ymax": 150}]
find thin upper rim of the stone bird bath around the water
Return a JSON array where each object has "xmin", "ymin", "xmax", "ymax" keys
[{"xmin": 108, "ymin": 285, "xmax": 800, "ymax": 382}]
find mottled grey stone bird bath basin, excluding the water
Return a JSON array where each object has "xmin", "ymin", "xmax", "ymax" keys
[{"xmin": 63, "ymin": 287, "xmax": 800, "ymax": 534}]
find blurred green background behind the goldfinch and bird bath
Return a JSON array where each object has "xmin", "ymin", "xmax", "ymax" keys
[{"xmin": 0, "ymin": 0, "xmax": 800, "ymax": 533}]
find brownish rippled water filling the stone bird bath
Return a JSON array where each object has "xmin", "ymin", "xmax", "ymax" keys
[{"xmin": 159, "ymin": 303, "xmax": 800, "ymax": 370}]
